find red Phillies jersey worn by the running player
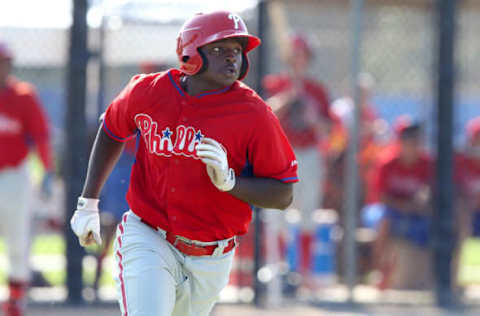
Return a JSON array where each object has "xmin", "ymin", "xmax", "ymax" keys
[{"xmin": 103, "ymin": 69, "xmax": 298, "ymax": 241}]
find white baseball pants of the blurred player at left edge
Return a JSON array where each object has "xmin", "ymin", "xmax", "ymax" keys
[{"xmin": 0, "ymin": 162, "xmax": 32, "ymax": 282}]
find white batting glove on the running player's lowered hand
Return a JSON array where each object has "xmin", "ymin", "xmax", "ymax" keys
[{"xmin": 70, "ymin": 197, "xmax": 102, "ymax": 247}]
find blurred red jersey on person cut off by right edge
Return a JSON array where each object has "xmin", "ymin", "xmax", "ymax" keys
[{"xmin": 455, "ymin": 154, "xmax": 480, "ymax": 209}]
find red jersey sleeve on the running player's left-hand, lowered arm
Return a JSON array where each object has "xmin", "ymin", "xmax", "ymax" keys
[{"xmin": 102, "ymin": 75, "xmax": 144, "ymax": 142}]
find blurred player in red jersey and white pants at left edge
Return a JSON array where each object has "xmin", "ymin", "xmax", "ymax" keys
[{"xmin": 0, "ymin": 42, "xmax": 52, "ymax": 316}]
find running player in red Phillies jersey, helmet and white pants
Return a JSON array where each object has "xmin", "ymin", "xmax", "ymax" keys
[{"xmin": 71, "ymin": 11, "xmax": 298, "ymax": 316}]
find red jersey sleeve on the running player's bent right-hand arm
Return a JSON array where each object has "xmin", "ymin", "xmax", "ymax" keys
[{"xmin": 247, "ymin": 108, "xmax": 299, "ymax": 183}]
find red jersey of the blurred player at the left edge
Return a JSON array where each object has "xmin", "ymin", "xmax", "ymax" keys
[{"xmin": 0, "ymin": 78, "xmax": 51, "ymax": 170}]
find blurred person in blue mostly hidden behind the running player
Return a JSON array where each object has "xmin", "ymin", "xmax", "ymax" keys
[{"xmin": 93, "ymin": 61, "xmax": 169, "ymax": 298}]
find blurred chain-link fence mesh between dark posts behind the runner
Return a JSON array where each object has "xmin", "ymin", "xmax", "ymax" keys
[{"xmin": 0, "ymin": 0, "xmax": 480, "ymax": 312}]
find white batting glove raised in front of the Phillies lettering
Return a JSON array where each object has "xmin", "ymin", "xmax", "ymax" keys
[{"xmin": 197, "ymin": 138, "xmax": 235, "ymax": 192}]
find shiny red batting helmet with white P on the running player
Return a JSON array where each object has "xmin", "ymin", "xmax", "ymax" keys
[{"xmin": 177, "ymin": 11, "xmax": 261, "ymax": 80}]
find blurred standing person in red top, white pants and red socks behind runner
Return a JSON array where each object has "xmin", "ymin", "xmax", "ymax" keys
[{"xmin": 263, "ymin": 35, "xmax": 334, "ymax": 286}]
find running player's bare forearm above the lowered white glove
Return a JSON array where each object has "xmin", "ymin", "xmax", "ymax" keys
[{"xmin": 82, "ymin": 127, "xmax": 125, "ymax": 199}]
